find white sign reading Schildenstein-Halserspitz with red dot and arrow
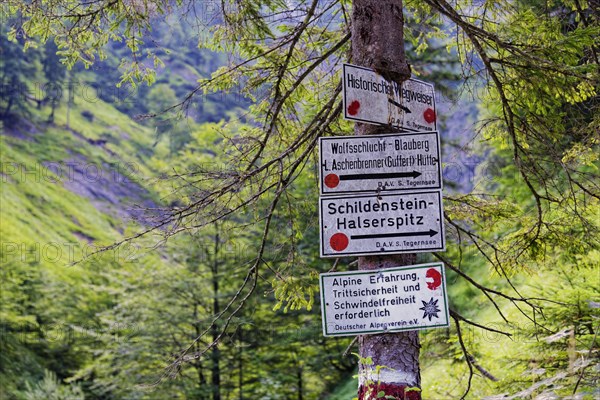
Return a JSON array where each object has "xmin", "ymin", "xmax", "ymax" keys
[{"xmin": 319, "ymin": 191, "xmax": 446, "ymax": 257}]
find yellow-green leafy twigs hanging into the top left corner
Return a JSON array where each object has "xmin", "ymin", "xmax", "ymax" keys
[{"xmin": 6, "ymin": 1, "xmax": 173, "ymax": 85}]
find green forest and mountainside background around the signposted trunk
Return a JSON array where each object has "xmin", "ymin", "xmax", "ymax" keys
[{"xmin": 0, "ymin": 1, "xmax": 600, "ymax": 399}]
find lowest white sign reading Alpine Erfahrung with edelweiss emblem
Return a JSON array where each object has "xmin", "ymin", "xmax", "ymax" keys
[{"xmin": 319, "ymin": 263, "xmax": 449, "ymax": 336}]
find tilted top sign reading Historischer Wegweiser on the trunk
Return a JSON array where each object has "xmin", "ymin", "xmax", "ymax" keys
[{"xmin": 342, "ymin": 64, "xmax": 437, "ymax": 132}]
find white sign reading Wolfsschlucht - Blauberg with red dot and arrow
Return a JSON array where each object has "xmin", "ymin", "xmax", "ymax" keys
[{"xmin": 319, "ymin": 132, "xmax": 442, "ymax": 195}]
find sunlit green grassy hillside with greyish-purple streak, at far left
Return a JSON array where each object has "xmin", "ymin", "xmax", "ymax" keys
[{"xmin": 0, "ymin": 81, "xmax": 156, "ymax": 243}]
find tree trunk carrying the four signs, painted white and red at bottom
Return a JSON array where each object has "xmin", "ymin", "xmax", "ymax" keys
[{"xmin": 352, "ymin": 0, "xmax": 421, "ymax": 400}]
